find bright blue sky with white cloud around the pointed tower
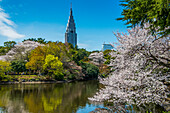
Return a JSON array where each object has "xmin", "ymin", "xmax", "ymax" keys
[{"xmin": 0, "ymin": 0, "xmax": 126, "ymax": 51}]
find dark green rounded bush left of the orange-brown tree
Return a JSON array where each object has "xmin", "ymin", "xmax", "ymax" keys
[{"xmin": 11, "ymin": 60, "xmax": 26, "ymax": 73}]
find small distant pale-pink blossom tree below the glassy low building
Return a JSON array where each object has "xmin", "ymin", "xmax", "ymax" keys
[{"xmin": 88, "ymin": 52, "xmax": 106, "ymax": 65}]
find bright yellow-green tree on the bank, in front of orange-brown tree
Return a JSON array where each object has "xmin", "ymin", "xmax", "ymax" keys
[{"xmin": 43, "ymin": 54, "xmax": 64, "ymax": 80}]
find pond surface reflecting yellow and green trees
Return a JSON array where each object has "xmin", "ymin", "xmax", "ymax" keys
[{"xmin": 0, "ymin": 81, "xmax": 99, "ymax": 113}]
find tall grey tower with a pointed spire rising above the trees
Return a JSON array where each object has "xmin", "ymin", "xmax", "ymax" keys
[{"xmin": 65, "ymin": 7, "xmax": 77, "ymax": 47}]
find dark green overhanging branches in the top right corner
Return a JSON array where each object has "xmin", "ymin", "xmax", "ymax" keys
[{"xmin": 117, "ymin": 0, "xmax": 170, "ymax": 36}]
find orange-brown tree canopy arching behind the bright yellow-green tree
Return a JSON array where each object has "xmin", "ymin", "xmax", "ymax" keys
[{"xmin": 26, "ymin": 42, "xmax": 72, "ymax": 74}]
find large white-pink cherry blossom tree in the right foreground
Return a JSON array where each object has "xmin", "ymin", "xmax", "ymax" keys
[{"xmin": 89, "ymin": 27, "xmax": 170, "ymax": 105}]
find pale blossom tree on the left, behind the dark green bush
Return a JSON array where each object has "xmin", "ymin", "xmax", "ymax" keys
[{"xmin": 0, "ymin": 41, "xmax": 43, "ymax": 61}]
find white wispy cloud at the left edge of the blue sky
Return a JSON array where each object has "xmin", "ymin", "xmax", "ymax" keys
[{"xmin": 0, "ymin": 5, "xmax": 25, "ymax": 40}]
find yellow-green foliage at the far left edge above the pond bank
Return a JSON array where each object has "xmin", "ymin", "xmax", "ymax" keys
[{"xmin": 0, "ymin": 60, "xmax": 11, "ymax": 80}]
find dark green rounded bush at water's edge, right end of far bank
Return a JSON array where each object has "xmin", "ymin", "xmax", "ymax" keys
[{"xmin": 80, "ymin": 62, "xmax": 99, "ymax": 78}]
